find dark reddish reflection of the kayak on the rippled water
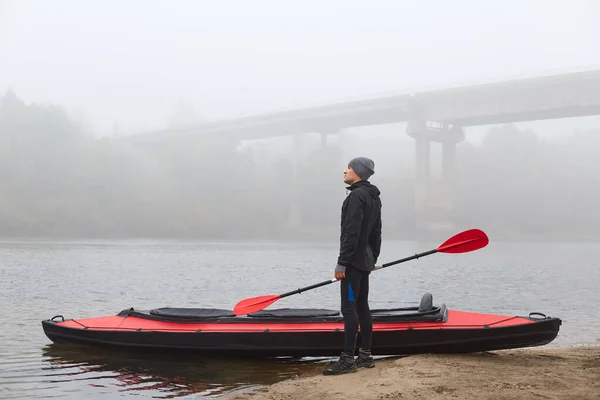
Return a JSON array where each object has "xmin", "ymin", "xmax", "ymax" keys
[{"xmin": 42, "ymin": 344, "xmax": 318, "ymax": 398}]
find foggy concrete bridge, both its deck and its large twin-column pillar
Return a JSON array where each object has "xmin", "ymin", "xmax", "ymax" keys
[{"xmin": 123, "ymin": 70, "xmax": 600, "ymax": 237}]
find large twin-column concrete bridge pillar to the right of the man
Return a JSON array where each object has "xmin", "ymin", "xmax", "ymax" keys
[{"xmin": 406, "ymin": 121, "xmax": 465, "ymax": 240}]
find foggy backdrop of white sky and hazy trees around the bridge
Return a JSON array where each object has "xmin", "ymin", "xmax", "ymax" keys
[{"xmin": 0, "ymin": 0, "xmax": 600, "ymax": 241}]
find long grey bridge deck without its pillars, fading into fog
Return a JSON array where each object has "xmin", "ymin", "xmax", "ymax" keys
[{"xmin": 123, "ymin": 70, "xmax": 600, "ymax": 144}]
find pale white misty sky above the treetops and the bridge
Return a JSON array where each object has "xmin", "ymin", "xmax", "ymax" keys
[{"xmin": 0, "ymin": 0, "xmax": 600, "ymax": 134}]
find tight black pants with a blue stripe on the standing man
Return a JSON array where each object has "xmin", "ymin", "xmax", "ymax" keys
[{"xmin": 340, "ymin": 267, "xmax": 373, "ymax": 355}]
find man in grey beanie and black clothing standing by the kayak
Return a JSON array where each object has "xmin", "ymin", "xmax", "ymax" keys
[{"xmin": 323, "ymin": 157, "xmax": 381, "ymax": 375}]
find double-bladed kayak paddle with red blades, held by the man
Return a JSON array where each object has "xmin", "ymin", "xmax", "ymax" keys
[{"xmin": 233, "ymin": 229, "xmax": 489, "ymax": 315}]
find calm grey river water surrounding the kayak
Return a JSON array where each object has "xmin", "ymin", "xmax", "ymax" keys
[{"xmin": 0, "ymin": 238, "xmax": 600, "ymax": 399}]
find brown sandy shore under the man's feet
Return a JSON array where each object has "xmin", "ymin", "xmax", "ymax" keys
[{"xmin": 228, "ymin": 347, "xmax": 600, "ymax": 400}]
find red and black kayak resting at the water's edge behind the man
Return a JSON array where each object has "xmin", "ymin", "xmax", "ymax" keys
[{"xmin": 42, "ymin": 293, "xmax": 562, "ymax": 357}]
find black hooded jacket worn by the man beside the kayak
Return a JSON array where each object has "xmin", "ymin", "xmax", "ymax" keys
[{"xmin": 338, "ymin": 180, "xmax": 381, "ymax": 271}]
